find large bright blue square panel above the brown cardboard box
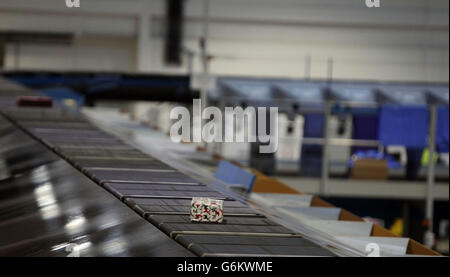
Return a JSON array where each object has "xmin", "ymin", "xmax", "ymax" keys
[{"xmin": 378, "ymin": 105, "xmax": 429, "ymax": 148}]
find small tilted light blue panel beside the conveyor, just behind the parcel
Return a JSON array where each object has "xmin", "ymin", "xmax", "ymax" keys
[{"xmin": 215, "ymin": 161, "xmax": 256, "ymax": 192}]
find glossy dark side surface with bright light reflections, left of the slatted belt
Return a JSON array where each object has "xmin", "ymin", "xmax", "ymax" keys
[{"xmin": 0, "ymin": 118, "xmax": 192, "ymax": 256}]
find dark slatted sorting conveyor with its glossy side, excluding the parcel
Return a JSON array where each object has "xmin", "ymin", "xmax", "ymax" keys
[{"xmin": 0, "ymin": 76, "xmax": 336, "ymax": 257}]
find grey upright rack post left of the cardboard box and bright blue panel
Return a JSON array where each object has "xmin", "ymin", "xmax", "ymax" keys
[{"xmin": 319, "ymin": 100, "xmax": 332, "ymax": 195}]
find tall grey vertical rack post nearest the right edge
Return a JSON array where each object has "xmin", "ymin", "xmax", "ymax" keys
[{"xmin": 424, "ymin": 104, "xmax": 437, "ymax": 248}]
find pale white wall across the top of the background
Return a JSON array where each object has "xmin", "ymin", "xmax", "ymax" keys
[{"xmin": 0, "ymin": 0, "xmax": 449, "ymax": 82}]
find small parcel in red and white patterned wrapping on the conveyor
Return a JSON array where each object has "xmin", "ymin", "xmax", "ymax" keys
[{"xmin": 190, "ymin": 197, "xmax": 223, "ymax": 223}]
